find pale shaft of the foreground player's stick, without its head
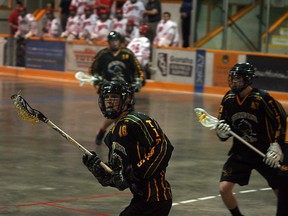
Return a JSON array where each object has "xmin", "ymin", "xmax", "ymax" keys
[{"xmin": 45, "ymin": 119, "xmax": 112, "ymax": 173}]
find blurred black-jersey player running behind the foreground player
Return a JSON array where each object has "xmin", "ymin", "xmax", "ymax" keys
[{"xmin": 89, "ymin": 31, "xmax": 145, "ymax": 145}]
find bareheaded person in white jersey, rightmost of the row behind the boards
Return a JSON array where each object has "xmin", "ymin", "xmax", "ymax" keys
[{"xmin": 153, "ymin": 12, "xmax": 179, "ymax": 47}]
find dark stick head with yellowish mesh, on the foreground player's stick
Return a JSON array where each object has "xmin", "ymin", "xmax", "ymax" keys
[{"xmin": 11, "ymin": 94, "xmax": 47, "ymax": 124}]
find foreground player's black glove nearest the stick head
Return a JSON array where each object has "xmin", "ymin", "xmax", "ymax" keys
[{"xmin": 82, "ymin": 151, "xmax": 112, "ymax": 187}]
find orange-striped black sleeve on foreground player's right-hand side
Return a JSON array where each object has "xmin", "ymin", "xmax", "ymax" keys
[{"xmin": 121, "ymin": 115, "xmax": 173, "ymax": 179}]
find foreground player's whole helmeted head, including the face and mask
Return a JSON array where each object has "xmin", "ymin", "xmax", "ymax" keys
[{"xmin": 98, "ymin": 80, "xmax": 134, "ymax": 119}]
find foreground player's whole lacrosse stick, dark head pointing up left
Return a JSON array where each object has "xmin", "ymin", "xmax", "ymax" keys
[{"xmin": 11, "ymin": 93, "xmax": 112, "ymax": 173}]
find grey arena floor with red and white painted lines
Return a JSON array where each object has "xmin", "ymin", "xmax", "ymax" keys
[{"xmin": 0, "ymin": 76, "xmax": 288, "ymax": 216}]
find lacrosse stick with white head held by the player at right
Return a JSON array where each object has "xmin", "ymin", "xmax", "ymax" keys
[{"xmin": 194, "ymin": 108, "xmax": 265, "ymax": 157}]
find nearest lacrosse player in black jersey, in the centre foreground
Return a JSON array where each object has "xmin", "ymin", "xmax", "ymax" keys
[{"xmin": 83, "ymin": 80, "xmax": 174, "ymax": 216}]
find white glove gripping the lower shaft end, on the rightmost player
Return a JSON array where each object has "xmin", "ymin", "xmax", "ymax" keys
[{"xmin": 263, "ymin": 143, "xmax": 283, "ymax": 168}]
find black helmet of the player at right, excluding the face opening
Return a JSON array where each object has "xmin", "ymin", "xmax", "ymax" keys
[{"xmin": 228, "ymin": 62, "xmax": 255, "ymax": 93}]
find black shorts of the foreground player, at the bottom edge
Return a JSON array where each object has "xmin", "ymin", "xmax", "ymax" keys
[{"xmin": 120, "ymin": 197, "xmax": 172, "ymax": 216}]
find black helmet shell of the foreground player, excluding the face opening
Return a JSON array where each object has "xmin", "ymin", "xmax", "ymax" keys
[{"xmin": 98, "ymin": 80, "xmax": 134, "ymax": 119}]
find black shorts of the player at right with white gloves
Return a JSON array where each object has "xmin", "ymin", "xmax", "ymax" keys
[{"xmin": 220, "ymin": 156, "xmax": 278, "ymax": 189}]
